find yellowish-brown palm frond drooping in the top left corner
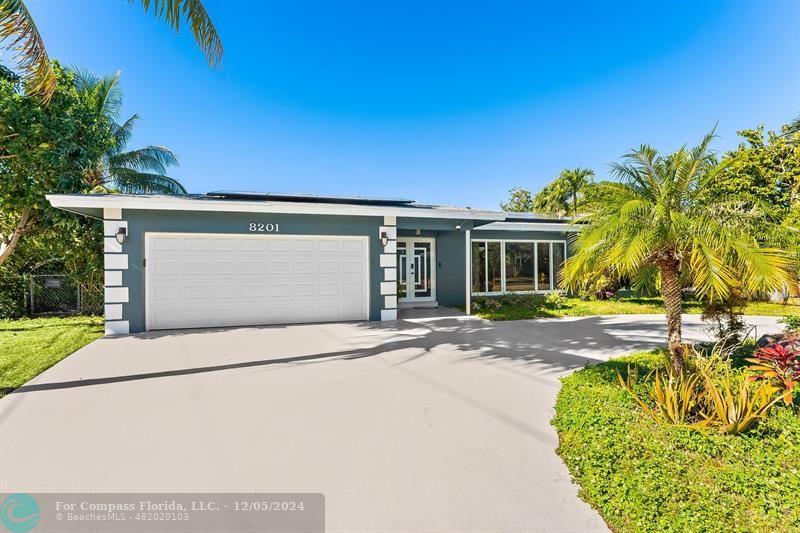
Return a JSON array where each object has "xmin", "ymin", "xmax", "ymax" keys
[{"xmin": 0, "ymin": 0, "xmax": 56, "ymax": 103}]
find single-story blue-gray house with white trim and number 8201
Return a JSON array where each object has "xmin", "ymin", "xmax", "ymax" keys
[{"xmin": 47, "ymin": 192, "xmax": 575, "ymax": 334}]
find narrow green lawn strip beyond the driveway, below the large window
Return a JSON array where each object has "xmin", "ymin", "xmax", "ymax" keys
[{"xmin": 466, "ymin": 297, "xmax": 800, "ymax": 320}]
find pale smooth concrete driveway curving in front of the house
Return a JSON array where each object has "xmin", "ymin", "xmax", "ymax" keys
[{"xmin": 0, "ymin": 310, "xmax": 778, "ymax": 532}]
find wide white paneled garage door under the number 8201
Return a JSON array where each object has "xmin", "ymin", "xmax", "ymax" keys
[{"xmin": 145, "ymin": 233, "xmax": 369, "ymax": 329}]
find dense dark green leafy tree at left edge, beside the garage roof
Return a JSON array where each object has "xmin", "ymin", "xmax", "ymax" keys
[{"xmin": 0, "ymin": 63, "xmax": 114, "ymax": 264}]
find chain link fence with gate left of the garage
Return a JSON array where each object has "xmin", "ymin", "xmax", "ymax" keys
[{"xmin": 27, "ymin": 274, "xmax": 103, "ymax": 316}]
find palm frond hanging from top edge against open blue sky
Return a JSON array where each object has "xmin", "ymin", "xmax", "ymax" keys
[{"xmin": 134, "ymin": 0, "xmax": 223, "ymax": 67}]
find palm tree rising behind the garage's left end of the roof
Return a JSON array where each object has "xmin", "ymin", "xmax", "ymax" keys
[{"xmin": 76, "ymin": 71, "xmax": 186, "ymax": 194}]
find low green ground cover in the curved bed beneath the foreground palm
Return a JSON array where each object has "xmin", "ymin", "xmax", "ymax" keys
[{"xmin": 552, "ymin": 352, "xmax": 800, "ymax": 532}]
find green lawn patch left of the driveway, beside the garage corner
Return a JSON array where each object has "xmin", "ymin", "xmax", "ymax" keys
[{"xmin": 0, "ymin": 316, "xmax": 103, "ymax": 397}]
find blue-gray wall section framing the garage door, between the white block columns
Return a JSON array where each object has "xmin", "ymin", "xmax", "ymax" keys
[{"xmin": 122, "ymin": 210, "xmax": 383, "ymax": 333}]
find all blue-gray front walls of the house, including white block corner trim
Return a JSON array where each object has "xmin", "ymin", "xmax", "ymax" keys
[{"xmin": 105, "ymin": 210, "xmax": 580, "ymax": 333}]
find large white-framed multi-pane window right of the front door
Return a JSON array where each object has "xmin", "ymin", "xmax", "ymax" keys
[{"xmin": 472, "ymin": 240, "xmax": 566, "ymax": 294}]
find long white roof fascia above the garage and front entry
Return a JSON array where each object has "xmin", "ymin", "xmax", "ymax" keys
[{"xmin": 47, "ymin": 194, "xmax": 506, "ymax": 220}]
